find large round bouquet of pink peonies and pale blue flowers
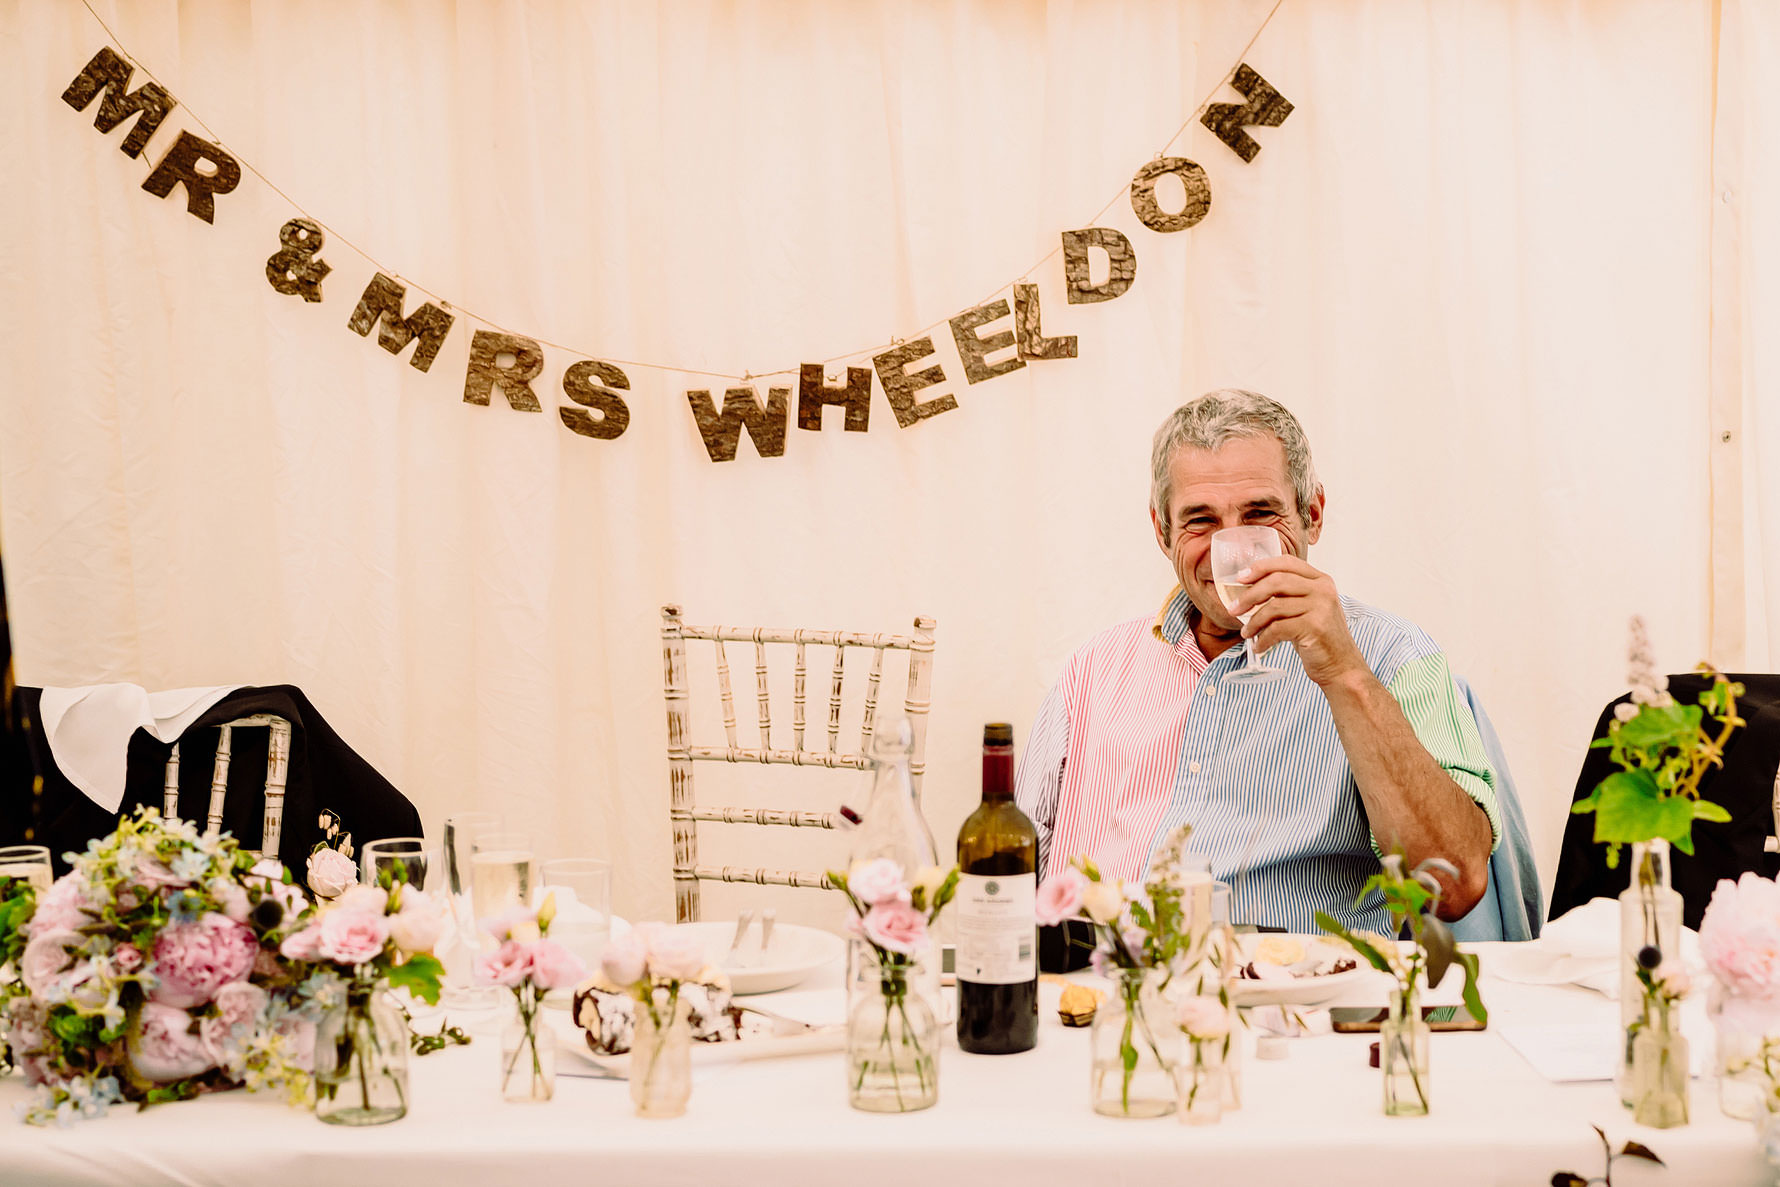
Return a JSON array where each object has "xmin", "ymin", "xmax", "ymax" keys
[{"xmin": 0, "ymin": 808, "xmax": 315, "ymax": 1125}]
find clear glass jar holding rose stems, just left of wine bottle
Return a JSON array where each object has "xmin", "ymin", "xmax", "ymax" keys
[{"xmin": 847, "ymin": 961, "xmax": 940, "ymax": 1112}]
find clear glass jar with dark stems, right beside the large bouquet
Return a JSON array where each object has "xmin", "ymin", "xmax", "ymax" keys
[{"xmin": 315, "ymin": 984, "xmax": 408, "ymax": 1125}]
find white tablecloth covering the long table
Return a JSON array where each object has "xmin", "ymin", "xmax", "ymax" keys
[{"xmin": 0, "ymin": 945, "xmax": 1769, "ymax": 1187}]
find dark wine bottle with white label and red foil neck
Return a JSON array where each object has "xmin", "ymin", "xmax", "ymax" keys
[{"xmin": 952, "ymin": 723, "xmax": 1038, "ymax": 1055}]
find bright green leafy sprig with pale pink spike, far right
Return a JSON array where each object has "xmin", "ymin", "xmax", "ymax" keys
[{"xmin": 1570, "ymin": 618, "xmax": 1746, "ymax": 867}]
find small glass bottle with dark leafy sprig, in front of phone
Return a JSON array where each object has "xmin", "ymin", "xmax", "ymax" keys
[{"xmin": 1315, "ymin": 852, "xmax": 1490, "ymax": 1116}]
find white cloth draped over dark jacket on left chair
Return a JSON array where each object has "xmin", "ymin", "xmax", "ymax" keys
[{"xmin": 37, "ymin": 683, "xmax": 240, "ymax": 812}]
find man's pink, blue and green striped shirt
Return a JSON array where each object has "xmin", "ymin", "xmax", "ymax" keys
[{"xmin": 1015, "ymin": 585, "xmax": 1502, "ymax": 933}]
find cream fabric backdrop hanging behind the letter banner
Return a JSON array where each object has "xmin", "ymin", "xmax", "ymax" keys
[{"xmin": 0, "ymin": 0, "xmax": 1751, "ymax": 915}]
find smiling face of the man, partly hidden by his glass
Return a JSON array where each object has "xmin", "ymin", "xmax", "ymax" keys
[{"xmin": 1150, "ymin": 434, "xmax": 1323, "ymax": 632}]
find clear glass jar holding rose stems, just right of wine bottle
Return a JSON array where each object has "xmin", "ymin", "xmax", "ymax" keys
[{"xmin": 1089, "ymin": 968, "xmax": 1181, "ymax": 1118}]
